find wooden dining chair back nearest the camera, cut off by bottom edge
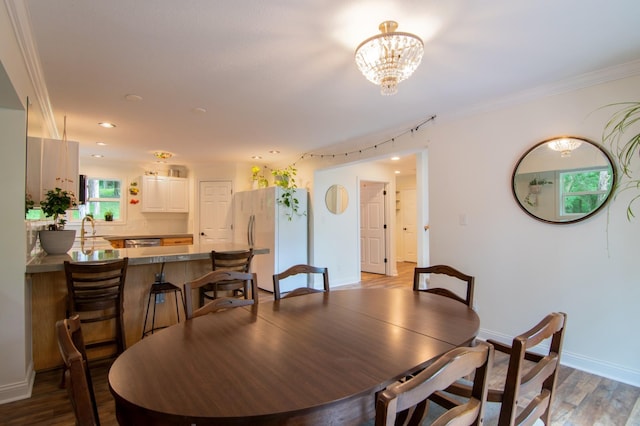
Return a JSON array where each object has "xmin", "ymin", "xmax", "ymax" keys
[{"xmin": 375, "ymin": 343, "xmax": 493, "ymax": 426}]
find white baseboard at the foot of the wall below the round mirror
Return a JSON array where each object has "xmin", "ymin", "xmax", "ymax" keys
[{"xmin": 478, "ymin": 329, "xmax": 640, "ymax": 387}]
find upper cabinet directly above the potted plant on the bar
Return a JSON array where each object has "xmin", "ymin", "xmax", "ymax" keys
[{"xmin": 26, "ymin": 137, "xmax": 80, "ymax": 205}]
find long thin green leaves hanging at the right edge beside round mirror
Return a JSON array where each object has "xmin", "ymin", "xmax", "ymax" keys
[{"xmin": 602, "ymin": 102, "xmax": 640, "ymax": 220}]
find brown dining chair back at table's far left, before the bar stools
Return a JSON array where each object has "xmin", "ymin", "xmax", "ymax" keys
[{"xmin": 184, "ymin": 271, "xmax": 259, "ymax": 319}]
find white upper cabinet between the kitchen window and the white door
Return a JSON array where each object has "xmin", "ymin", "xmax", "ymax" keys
[{"xmin": 141, "ymin": 175, "xmax": 189, "ymax": 213}]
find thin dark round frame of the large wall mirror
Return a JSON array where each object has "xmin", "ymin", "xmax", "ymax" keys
[{"xmin": 511, "ymin": 136, "xmax": 618, "ymax": 225}]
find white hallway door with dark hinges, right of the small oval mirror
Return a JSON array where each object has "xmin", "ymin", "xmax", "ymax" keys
[{"xmin": 360, "ymin": 182, "xmax": 386, "ymax": 274}]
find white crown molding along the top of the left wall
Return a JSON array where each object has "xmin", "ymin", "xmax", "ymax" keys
[{"xmin": 5, "ymin": 0, "xmax": 60, "ymax": 139}]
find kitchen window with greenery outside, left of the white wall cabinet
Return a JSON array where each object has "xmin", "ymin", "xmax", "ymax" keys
[{"xmin": 69, "ymin": 177, "xmax": 124, "ymax": 221}]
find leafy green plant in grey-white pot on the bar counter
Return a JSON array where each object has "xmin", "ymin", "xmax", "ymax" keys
[{"xmin": 38, "ymin": 188, "xmax": 78, "ymax": 254}]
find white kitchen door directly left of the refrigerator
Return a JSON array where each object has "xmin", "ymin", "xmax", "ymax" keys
[{"xmin": 200, "ymin": 181, "xmax": 233, "ymax": 244}]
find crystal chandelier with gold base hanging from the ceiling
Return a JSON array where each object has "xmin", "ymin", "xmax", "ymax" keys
[{"xmin": 356, "ymin": 21, "xmax": 424, "ymax": 96}]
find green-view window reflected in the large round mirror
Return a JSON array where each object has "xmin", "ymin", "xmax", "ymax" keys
[{"xmin": 559, "ymin": 168, "xmax": 613, "ymax": 217}]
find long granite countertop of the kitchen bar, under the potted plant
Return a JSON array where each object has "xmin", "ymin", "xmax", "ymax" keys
[{"xmin": 26, "ymin": 243, "xmax": 269, "ymax": 274}]
